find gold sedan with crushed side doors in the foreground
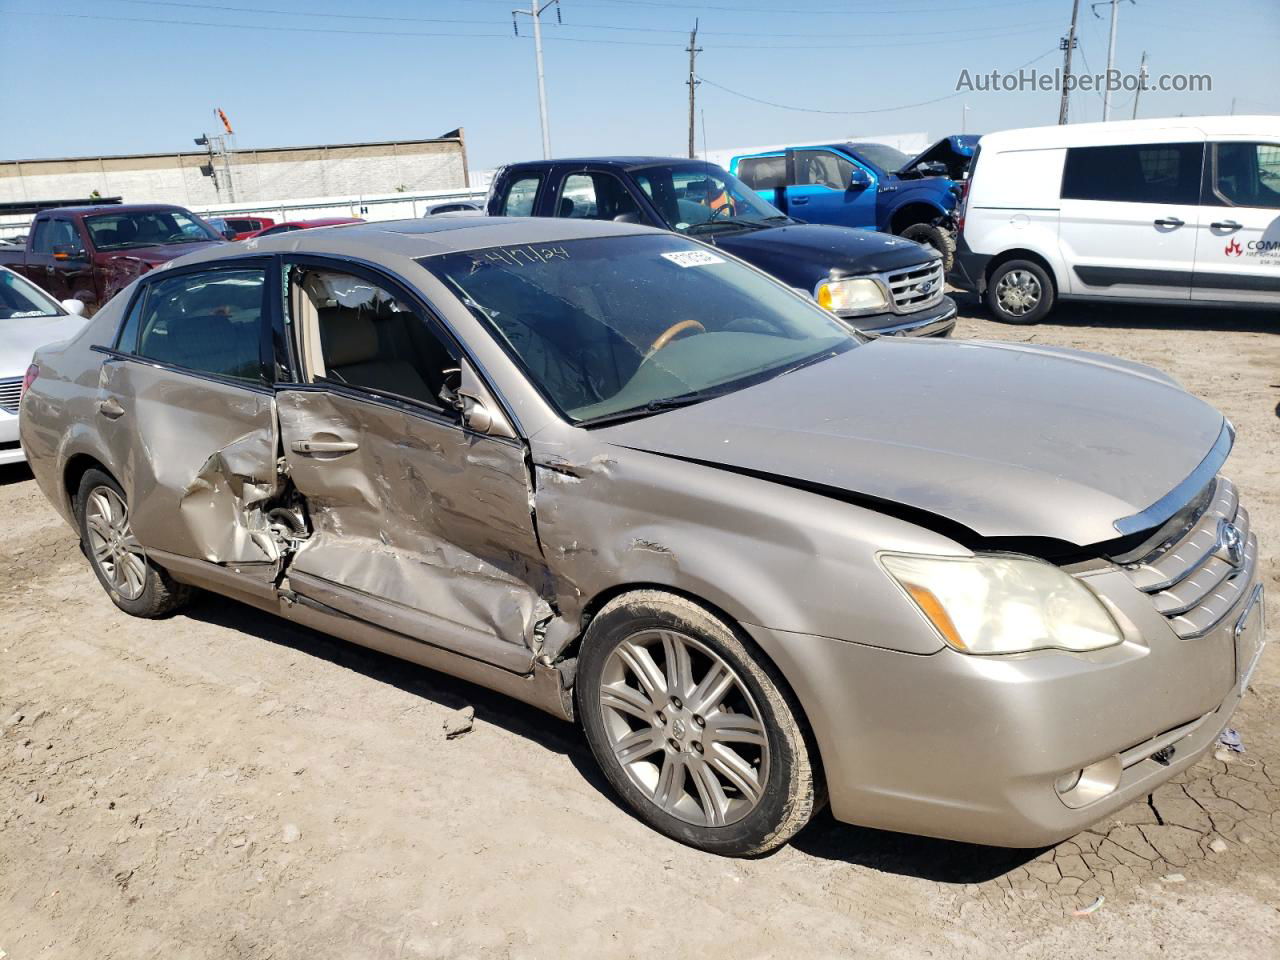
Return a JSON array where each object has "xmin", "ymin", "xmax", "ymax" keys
[{"xmin": 20, "ymin": 218, "xmax": 1263, "ymax": 855}]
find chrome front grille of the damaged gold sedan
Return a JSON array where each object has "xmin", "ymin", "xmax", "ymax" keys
[{"xmin": 1124, "ymin": 476, "xmax": 1258, "ymax": 640}]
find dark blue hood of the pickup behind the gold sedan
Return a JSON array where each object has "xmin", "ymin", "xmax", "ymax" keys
[{"xmin": 699, "ymin": 223, "xmax": 932, "ymax": 292}]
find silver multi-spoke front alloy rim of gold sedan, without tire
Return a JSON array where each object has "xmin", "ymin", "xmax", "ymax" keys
[{"xmin": 600, "ymin": 630, "xmax": 769, "ymax": 827}]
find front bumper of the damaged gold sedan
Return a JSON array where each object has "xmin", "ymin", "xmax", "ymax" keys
[{"xmin": 745, "ymin": 571, "xmax": 1262, "ymax": 847}]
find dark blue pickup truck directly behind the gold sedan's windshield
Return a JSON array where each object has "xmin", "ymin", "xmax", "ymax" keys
[{"xmin": 488, "ymin": 156, "xmax": 956, "ymax": 337}]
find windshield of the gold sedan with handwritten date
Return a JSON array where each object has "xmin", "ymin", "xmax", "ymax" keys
[{"xmin": 417, "ymin": 234, "xmax": 859, "ymax": 422}]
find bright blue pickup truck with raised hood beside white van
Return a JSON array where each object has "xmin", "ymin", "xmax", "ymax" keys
[{"xmin": 730, "ymin": 136, "xmax": 978, "ymax": 269}]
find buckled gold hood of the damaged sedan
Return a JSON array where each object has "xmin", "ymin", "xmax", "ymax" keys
[{"xmin": 596, "ymin": 339, "xmax": 1225, "ymax": 547}]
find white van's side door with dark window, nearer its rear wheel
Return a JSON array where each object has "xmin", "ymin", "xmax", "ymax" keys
[{"xmin": 1059, "ymin": 131, "xmax": 1204, "ymax": 300}]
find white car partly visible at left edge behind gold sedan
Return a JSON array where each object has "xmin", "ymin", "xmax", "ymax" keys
[{"xmin": 0, "ymin": 266, "xmax": 84, "ymax": 465}]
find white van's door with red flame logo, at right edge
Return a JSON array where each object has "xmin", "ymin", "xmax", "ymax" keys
[{"xmin": 1192, "ymin": 138, "xmax": 1280, "ymax": 303}]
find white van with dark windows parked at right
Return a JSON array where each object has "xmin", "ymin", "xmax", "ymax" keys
[{"xmin": 950, "ymin": 116, "xmax": 1280, "ymax": 324}]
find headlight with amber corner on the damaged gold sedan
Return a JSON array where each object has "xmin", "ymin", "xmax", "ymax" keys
[{"xmin": 881, "ymin": 554, "xmax": 1124, "ymax": 654}]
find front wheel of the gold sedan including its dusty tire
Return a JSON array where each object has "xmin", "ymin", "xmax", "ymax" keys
[{"xmin": 576, "ymin": 590, "xmax": 824, "ymax": 856}]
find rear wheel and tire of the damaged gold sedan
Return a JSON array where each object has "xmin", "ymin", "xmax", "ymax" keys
[{"xmin": 76, "ymin": 468, "xmax": 192, "ymax": 620}]
